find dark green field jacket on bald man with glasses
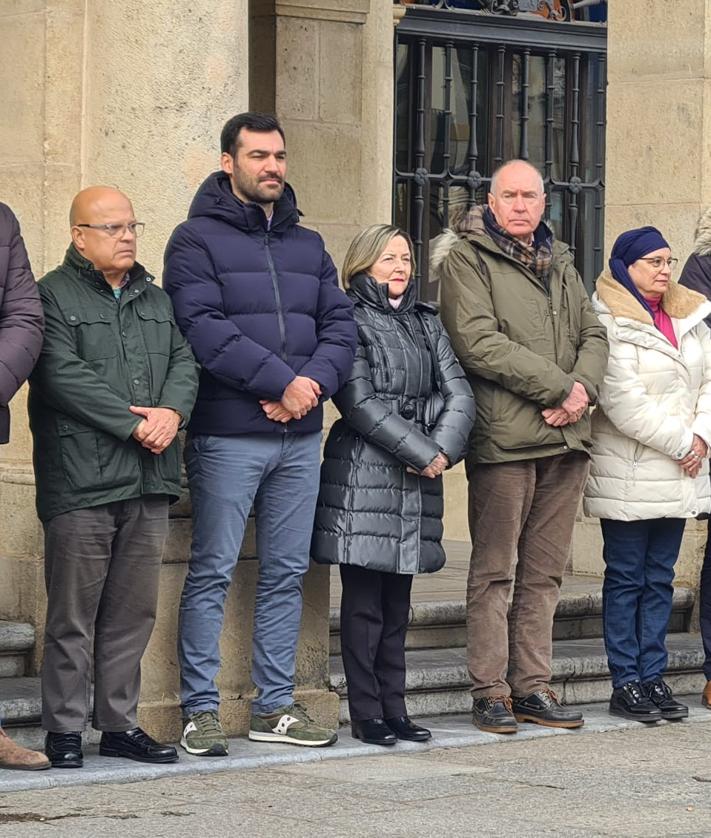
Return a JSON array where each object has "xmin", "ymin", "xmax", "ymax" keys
[{"xmin": 28, "ymin": 246, "xmax": 197, "ymax": 521}]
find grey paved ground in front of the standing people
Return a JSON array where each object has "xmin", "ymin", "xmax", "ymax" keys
[{"xmin": 0, "ymin": 707, "xmax": 711, "ymax": 838}]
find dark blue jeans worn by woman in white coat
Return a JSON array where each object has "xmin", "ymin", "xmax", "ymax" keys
[{"xmin": 600, "ymin": 518, "xmax": 686, "ymax": 687}]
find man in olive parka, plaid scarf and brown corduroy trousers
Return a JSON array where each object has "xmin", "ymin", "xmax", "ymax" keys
[{"xmin": 433, "ymin": 160, "xmax": 607, "ymax": 733}]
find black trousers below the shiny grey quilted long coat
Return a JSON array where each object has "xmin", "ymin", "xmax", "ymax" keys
[{"xmin": 339, "ymin": 565, "xmax": 412, "ymax": 721}]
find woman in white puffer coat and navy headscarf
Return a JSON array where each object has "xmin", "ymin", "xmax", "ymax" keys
[{"xmin": 584, "ymin": 227, "xmax": 711, "ymax": 722}]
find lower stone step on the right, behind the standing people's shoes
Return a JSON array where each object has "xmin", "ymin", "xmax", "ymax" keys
[{"xmin": 331, "ymin": 632, "xmax": 706, "ymax": 722}]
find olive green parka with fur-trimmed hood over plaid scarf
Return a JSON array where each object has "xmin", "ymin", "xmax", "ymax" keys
[{"xmin": 435, "ymin": 220, "xmax": 608, "ymax": 466}]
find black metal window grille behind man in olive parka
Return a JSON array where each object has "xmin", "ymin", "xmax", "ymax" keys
[{"xmin": 393, "ymin": 1, "xmax": 606, "ymax": 299}]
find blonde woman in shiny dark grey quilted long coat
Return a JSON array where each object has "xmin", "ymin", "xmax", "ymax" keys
[{"xmin": 311, "ymin": 224, "xmax": 474, "ymax": 745}]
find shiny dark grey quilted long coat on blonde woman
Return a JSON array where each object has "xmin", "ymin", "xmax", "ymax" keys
[{"xmin": 311, "ymin": 274, "xmax": 474, "ymax": 574}]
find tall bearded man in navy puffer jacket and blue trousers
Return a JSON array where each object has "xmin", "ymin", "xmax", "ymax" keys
[{"xmin": 164, "ymin": 113, "xmax": 356, "ymax": 756}]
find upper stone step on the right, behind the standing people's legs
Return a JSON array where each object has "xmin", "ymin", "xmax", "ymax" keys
[{"xmin": 330, "ymin": 576, "xmax": 694, "ymax": 655}]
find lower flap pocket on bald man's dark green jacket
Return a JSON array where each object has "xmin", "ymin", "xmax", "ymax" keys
[{"xmin": 57, "ymin": 417, "xmax": 139, "ymax": 492}]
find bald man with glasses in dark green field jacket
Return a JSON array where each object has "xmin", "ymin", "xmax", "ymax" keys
[{"xmin": 29, "ymin": 187, "xmax": 197, "ymax": 768}]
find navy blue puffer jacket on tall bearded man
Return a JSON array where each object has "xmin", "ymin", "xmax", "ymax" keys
[{"xmin": 163, "ymin": 172, "xmax": 356, "ymax": 436}]
